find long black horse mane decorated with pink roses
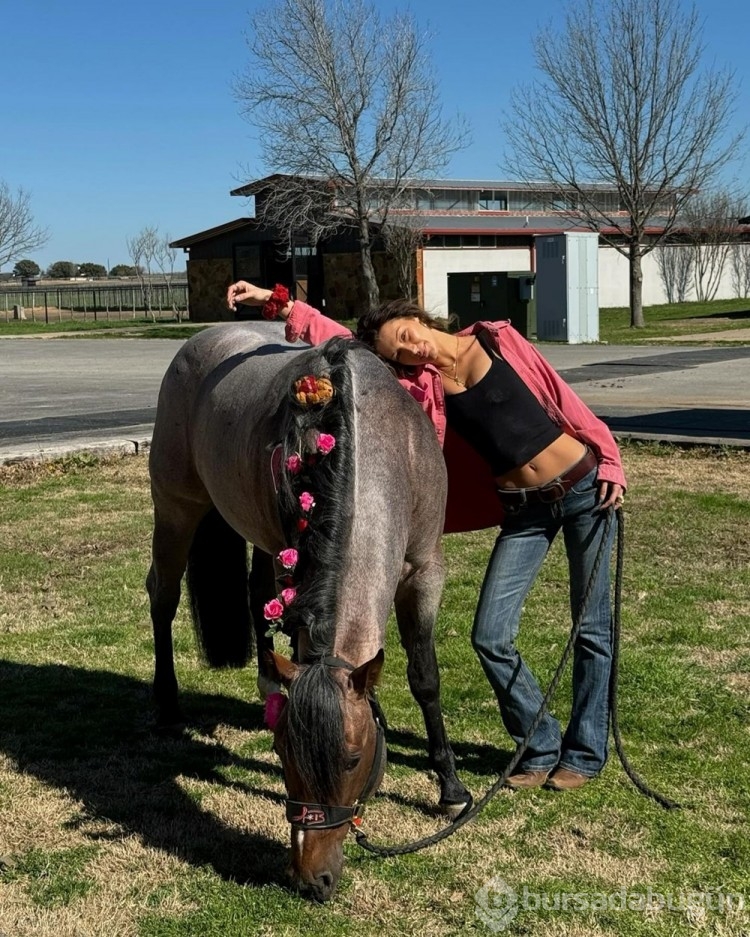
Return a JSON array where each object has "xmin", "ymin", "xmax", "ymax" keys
[{"xmin": 277, "ymin": 338, "xmax": 358, "ymax": 658}]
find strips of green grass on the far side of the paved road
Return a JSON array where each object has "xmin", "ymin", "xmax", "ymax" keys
[{"xmin": 0, "ymin": 299, "xmax": 750, "ymax": 345}]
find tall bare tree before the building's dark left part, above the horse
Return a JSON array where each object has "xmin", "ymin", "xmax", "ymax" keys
[{"xmin": 234, "ymin": 0, "xmax": 467, "ymax": 307}]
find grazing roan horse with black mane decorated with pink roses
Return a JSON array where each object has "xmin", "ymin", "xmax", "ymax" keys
[{"xmin": 147, "ymin": 323, "xmax": 471, "ymax": 902}]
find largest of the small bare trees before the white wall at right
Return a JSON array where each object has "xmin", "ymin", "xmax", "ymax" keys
[{"xmin": 680, "ymin": 191, "xmax": 741, "ymax": 302}]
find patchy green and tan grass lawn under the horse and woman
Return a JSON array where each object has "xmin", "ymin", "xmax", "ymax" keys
[{"xmin": 0, "ymin": 444, "xmax": 750, "ymax": 937}]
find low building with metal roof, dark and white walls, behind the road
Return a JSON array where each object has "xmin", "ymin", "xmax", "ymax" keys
[{"xmin": 172, "ymin": 175, "xmax": 748, "ymax": 326}]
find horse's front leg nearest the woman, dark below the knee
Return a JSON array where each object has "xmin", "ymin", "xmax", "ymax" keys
[{"xmin": 395, "ymin": 557, "xmax": 471, "ymax": 816}]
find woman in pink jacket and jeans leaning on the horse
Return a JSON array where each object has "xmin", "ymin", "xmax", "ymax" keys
[{"xmin": 227, "ymin": 281, "xmax": 625, "ymax": 791}]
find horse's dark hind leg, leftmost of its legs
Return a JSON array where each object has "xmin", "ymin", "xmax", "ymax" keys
[{"xmin": 146, "ymin": 508, "xmax": 205, "ymax": 727}]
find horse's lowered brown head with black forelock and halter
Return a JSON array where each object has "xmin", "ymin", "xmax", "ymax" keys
[{"xmin": 269, "ymin": 649, "xmax": 386, "ymax": 901}]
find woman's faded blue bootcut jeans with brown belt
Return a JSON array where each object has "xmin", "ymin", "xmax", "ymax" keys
[{"xmin": 472, "ymin": 468, "xmax": 616, "ymax": 777}]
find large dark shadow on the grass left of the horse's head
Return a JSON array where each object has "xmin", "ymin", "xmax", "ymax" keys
[{"xmin": 0, "ymin": 661, "xmax": 287, "ymax": 885}]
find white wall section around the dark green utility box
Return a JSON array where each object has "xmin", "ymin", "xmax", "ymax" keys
[{"xmin": 422, "ymin": 247, "xmax": 532, "ymax": 319}]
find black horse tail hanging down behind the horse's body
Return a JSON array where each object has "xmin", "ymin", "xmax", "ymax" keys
[{"xmin": 186, "ymin": 508, "xmax": 253, "ymax": 667}]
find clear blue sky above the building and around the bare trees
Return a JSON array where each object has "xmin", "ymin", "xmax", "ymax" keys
[{"xmin": 0, "ymin": 0, "xmax": 750, "ymax": 270}]
